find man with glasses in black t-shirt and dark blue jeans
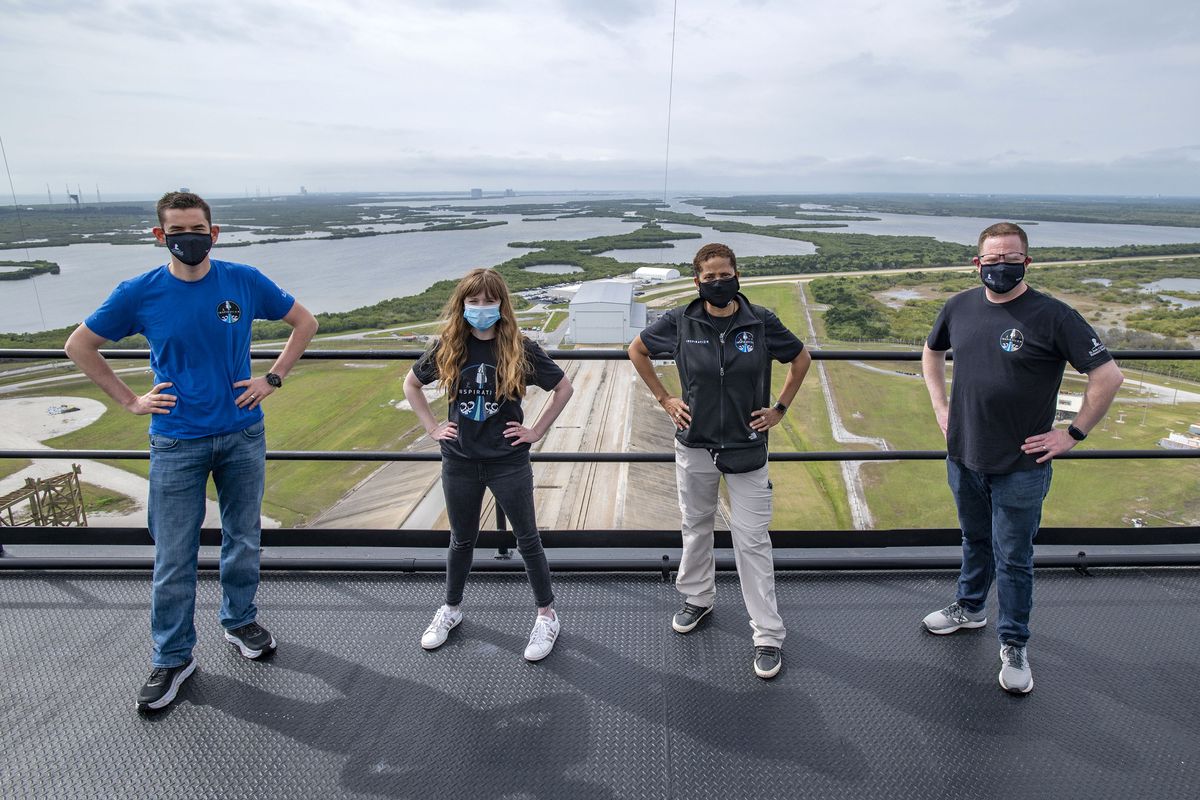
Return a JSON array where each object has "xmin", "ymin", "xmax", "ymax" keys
[{"xmin": 922, "ymin": 222, "xmax": 1124, "ymax": 694}]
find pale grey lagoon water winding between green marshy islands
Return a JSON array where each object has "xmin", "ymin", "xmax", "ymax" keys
[{"xmin": 7, "ymin": 193, "xmax": 1200, "ymax": 332}]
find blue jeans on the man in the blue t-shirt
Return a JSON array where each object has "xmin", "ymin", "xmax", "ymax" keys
[{"xmin": 149, "ymin": 421, "xmax": 266, "ymax": 667}]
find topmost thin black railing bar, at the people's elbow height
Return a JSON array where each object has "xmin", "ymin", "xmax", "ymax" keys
[{"xmin": 0, "ymin": 348, "xmax": 1200, "ymax": 361}]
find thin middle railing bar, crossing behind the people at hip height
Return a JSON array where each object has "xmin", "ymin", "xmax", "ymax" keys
[{"xmin": 0, "ymin": 449, "xmax": 1200, "ymax": 464}]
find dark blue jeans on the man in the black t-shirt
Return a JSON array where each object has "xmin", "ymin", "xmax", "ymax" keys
[{"xmin": 946, "ymin": 459, "xmax": 1052, "ymax": 646}]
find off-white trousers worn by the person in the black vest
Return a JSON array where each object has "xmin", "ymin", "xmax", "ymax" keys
[{"xmin": 676, "ymin": 439, "xmax": 786, "ymax": 648}]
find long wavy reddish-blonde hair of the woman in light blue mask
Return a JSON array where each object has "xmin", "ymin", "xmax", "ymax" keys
[{"xmin": 437, "ymin": 269, "xmax": 529, "ymax": 399}]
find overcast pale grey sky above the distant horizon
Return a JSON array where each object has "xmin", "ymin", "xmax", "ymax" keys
[{"xmin": 0, "ymin": 0, "xmax": 1200, "ymax": 201}]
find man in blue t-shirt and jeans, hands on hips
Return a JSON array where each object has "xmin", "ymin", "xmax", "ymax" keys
[{"xmin": 66, "ymin": 192, "xmax": 317, "ymax": 711}]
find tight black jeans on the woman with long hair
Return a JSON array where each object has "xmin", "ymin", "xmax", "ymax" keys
[{"xmin": 442, "ymin": 456, "xmax": 554, "ymax": 608}]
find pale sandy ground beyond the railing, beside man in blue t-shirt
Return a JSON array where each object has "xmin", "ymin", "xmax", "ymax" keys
[{"xmin": 0, "ymin": 395, "xmax": 278, "ymax": 528}]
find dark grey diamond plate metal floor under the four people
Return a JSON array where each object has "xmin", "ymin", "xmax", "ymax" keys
[{"xmin": 0, "ymin": 570, "xmax": 1200, "ymax": 800}]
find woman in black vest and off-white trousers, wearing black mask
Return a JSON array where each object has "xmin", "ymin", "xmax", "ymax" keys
[{"xmin": 629, "ymin": 243, "xmax": 811, "ymax": 678}]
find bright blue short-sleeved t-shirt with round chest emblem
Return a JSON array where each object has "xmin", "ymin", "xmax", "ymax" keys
[{"xmin": 84, "ymin": 260, "xmax": 295, "ymax": 439}]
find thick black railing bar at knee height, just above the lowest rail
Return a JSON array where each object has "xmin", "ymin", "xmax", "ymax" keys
[{"xmin": 0, "ymin": 527, "xmax": 1200, "ymax": 549}]
